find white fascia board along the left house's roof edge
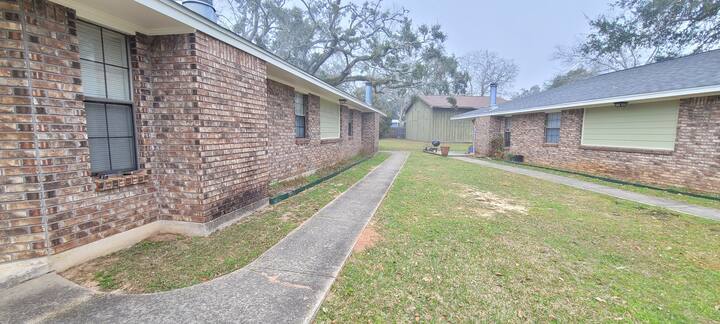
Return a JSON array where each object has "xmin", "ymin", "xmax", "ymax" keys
[{"xmin": 135, "ymin": 0, "xmax": 386, "ymax": 116}]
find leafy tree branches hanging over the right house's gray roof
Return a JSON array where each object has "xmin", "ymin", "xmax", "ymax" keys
[{"xmin": 557, "ymin": 0, "xmax": 720, "ymax": 70}]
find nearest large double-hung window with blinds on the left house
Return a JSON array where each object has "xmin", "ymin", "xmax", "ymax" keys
[{"xmin": 77, "ymin": 21, "xmax": 137, "ymax": 174}]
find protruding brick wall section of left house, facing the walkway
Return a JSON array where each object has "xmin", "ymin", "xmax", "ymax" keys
[{"xmin": 195, "ymin": 32, "xmax": 268, "ymax": 221}]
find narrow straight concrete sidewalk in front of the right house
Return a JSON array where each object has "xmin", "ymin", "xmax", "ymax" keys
[{"xmin": 454, "ymin": 157, "xmax": 720, "ymax": 221}]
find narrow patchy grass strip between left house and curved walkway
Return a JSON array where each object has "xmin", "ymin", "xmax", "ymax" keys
[{"xmin": 63, "ymin": 153, "xmax": 388, "ymax": 293}]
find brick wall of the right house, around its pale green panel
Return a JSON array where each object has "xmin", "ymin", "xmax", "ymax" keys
[{"xmin": 476, "ymin": 96, "xmax": 720, "ymax": 192}]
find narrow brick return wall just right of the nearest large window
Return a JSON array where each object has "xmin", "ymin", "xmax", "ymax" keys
[{"xmin": 142, "ymin": 34, "xmax": 204, "ymax": 222}]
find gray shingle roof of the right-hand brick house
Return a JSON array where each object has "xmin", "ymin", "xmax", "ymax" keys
[{"xmin": 453, "ymin": 50, "xmax": 720, "ymax": 119}]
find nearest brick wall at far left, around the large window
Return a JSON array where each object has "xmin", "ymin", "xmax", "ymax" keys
[{"xmin": 0, "ymin": 1, "xmax": 157, "ymax": 261}]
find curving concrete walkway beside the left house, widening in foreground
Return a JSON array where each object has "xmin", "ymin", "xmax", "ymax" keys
[{"xmin": 0, "ymin": 152, "xmax": 408, "ymax": 323}]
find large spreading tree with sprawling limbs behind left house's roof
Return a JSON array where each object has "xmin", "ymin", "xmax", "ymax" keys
[{"xmin": 220, "ymin": 0, "xmax": 468, "ymax": 93}]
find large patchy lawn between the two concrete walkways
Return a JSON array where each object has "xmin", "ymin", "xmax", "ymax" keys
[{"xmin": 317, "ymin": 153, "xmax": 720, "ymax": 323}]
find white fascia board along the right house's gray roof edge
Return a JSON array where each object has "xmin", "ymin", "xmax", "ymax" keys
[{"xmin": 450, "ymin": 85, "xmax": 720, "ymax": 120}]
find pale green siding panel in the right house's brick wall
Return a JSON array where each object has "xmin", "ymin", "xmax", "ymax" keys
[{"xmin": 582, "ymin": 101, "xmax": 679, "ymax": 150}]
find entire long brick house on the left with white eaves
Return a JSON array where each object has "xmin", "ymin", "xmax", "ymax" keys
[{"xmin": 0, "ymin": 0, "xmax": 382, "ymax": 286}]
